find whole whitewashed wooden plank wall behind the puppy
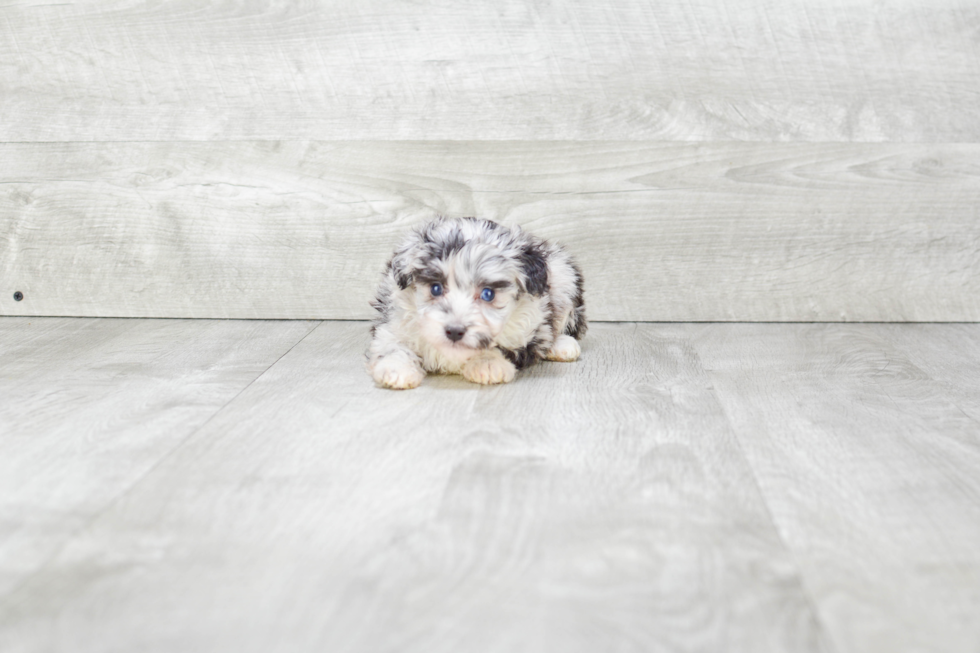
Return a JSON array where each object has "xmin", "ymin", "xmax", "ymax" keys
[{"xmin": 0, "ymin": 0, "xmax": 980, "ymax": 321}]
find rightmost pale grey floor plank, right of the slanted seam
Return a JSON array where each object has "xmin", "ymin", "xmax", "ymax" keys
[{"xmin": 685, "ymin": 325, "xmax": 980, "ymax": 653}]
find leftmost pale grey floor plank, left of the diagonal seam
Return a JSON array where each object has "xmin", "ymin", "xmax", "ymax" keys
[{"xmin": 0, "ymin": 318, "xmax": 314, "ymax": 600}]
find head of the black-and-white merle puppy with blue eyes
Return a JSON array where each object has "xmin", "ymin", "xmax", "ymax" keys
[{"xmin": 391, "ymin": 218, "xmax": 547, "ymax": 360}]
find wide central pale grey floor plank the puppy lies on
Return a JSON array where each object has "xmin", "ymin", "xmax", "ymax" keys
[{"xmin": 0, "ymin": 322, "xmax": 828, "ymax": 653}]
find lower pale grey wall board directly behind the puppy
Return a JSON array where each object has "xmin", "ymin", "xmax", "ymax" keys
[{"xmin": 0, "ymin": 142, "xmax": 980, "ymax": 321}]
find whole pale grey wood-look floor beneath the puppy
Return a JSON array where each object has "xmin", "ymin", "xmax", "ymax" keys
[{"xmin": 0, "ymin": 317, "xmax": 980, "ymax": 653}]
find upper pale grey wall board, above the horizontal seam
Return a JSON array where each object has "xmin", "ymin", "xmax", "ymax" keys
[{"xmin": 0, "ymin": 0, "xmax": 980, "ymax": 142}]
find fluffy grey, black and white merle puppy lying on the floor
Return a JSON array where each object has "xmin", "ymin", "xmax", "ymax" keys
[{"xmin": 367, "ymin": 218, "xmax": 587, "ymax": 389}]
